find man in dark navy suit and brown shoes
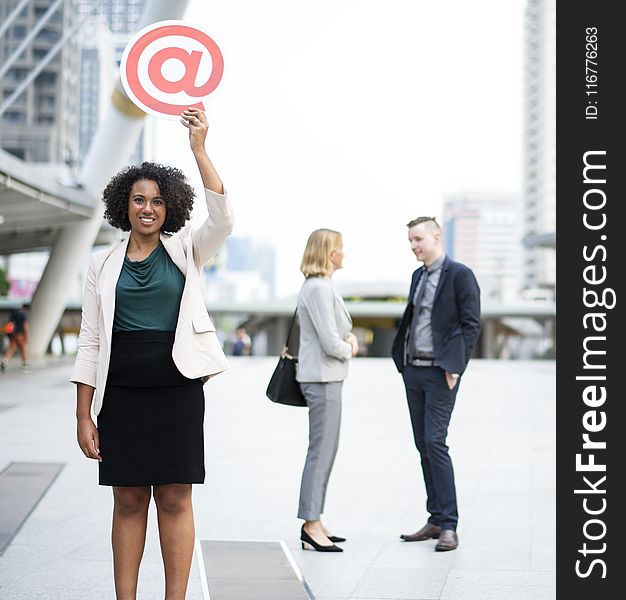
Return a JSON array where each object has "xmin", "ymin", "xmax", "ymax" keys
[{"xmin": 391, "ymin": 217, "xmax": 480, "ymax": 552}]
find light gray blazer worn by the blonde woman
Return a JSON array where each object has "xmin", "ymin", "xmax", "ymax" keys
[{"xmin": 296, "ymin": 277, "xmax": 352, "ymax": 383}]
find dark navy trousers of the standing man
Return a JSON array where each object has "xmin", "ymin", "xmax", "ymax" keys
[{"xmin": 402, "ymin": 365, "xmax": 460, "ymax": 531}]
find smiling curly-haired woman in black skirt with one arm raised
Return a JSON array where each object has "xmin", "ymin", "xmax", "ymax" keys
[{"xmin": 71, "ymin": 108, "xmax": 233, "ymax": 600}]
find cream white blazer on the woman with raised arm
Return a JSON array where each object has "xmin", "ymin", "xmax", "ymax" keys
[{"xmin": 71, "ymin": 190, "xmax": 234, "ymax": 415}]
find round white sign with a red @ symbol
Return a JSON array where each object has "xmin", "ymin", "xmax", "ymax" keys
[{"xmin": 120, "ymin": 21, "xmax": 224, "ymax": 118}]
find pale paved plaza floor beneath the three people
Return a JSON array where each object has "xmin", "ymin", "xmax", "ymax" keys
[{"xmin": 0, "ymin": 357, "xmax": 556, "ymax": 600}]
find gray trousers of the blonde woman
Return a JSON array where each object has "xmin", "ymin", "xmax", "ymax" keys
[{"xmin": 298, "ymin": 381, "xmax": 343, "ymax": 521}]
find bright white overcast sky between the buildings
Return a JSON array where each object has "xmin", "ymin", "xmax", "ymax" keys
[{"xmin": 149, "ymin": 0, "xmax": 525, "ymax": 297}]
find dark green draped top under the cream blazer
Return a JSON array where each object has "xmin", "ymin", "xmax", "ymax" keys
[{"xmin": 113, "ymin": 243, "xmax": 185, "ymax": 331}]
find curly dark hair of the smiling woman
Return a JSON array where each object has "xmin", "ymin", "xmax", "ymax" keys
[{"xmin": 102, "ymin": 162, "xmax": 196, "ymax": 233}]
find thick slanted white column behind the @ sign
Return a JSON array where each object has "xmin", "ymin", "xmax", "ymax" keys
[{"xmin": 29, "ymin": 0, "xmax": 188, "ymax": 358}]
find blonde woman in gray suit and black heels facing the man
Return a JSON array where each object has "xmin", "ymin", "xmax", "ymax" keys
[{"xmin": 297, "ymin": 229, "xmax": 359, "ymax": 552}]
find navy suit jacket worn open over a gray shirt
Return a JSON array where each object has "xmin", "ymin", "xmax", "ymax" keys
[{"xmin": 391, "ymin": 256, "xmax": 480, "ymax": 375}]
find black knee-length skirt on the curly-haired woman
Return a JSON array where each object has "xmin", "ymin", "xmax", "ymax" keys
[{"xmin": 98, "ymin": 331, "xmax": 204, "ymax": 486}]
